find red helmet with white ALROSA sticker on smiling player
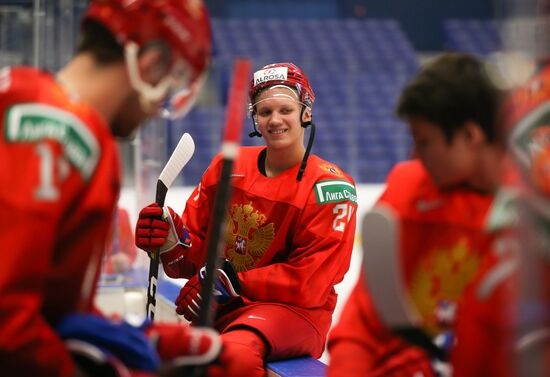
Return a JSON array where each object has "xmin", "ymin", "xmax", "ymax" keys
[{"xmin": 248, "ymin": 63, "xmax": 315, "ymax": 111}]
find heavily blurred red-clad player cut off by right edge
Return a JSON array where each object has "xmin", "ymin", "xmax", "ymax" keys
[{"xmin": 453, "ymin": 50, "xmax": 550, "ymax": 377}]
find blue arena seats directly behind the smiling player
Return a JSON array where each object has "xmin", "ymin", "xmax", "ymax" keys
[{"xmin": 168, "ymin": 19, "xmax": 418, "ymax": 185}]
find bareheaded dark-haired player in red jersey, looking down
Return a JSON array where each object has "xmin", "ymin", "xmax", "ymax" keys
[{"xmin": 328, "ymin": 53, "xmax": 502, "ymax": 377}]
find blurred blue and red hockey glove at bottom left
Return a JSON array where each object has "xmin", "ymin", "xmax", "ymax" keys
[{"xmin": 56, "ymin": 314, "xmax": 222, "ymax": 376}]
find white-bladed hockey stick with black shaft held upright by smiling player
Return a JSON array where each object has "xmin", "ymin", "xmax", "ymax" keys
[{"xmin": 145, "ymin": 133, "xmax": 195, "ymax": 321}]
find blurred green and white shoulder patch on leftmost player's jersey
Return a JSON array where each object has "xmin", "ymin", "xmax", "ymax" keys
[{"xmin": 4, "ymin": 103, "xmax": 100, "ymax": 180}]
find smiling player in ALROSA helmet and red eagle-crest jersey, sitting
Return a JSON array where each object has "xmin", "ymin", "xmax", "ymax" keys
[{"xmin": 136, "ymin": 63, "xmax": 357, "ymax": 377}]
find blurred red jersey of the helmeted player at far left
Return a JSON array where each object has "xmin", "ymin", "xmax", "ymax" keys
[{"xmin": 0, "ymin": 68, "xmax": 119, "ymax": 376}]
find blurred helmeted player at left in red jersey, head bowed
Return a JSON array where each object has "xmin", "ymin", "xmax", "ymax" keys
[{"xmin": 0, "ymin": 0, "xmax": 219, "ymax": 376}]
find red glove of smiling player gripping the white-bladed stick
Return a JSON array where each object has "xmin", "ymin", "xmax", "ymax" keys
[{"xmin": 135, "ymin": 203, "xmax": 191, "ymax": 253}]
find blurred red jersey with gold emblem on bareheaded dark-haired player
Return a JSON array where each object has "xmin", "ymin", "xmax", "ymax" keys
[{"xmin": 329, "ymin": 161, "xmax": 493, "ymax": 376}]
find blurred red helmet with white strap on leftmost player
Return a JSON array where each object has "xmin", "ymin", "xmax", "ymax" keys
[{"xmin": 83, "ymin": 0, "xmax": 212, "ymax": 118}]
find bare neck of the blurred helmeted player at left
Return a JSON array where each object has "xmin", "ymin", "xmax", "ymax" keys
[{"xmin": 56, "ymin": 54, "xmax": 129, "ymax": 123}]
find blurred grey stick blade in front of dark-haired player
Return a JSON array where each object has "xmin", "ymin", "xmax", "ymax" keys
[{"xmin": 361, "ymin": 204, "xmax": 447, "ymax": 361}]
